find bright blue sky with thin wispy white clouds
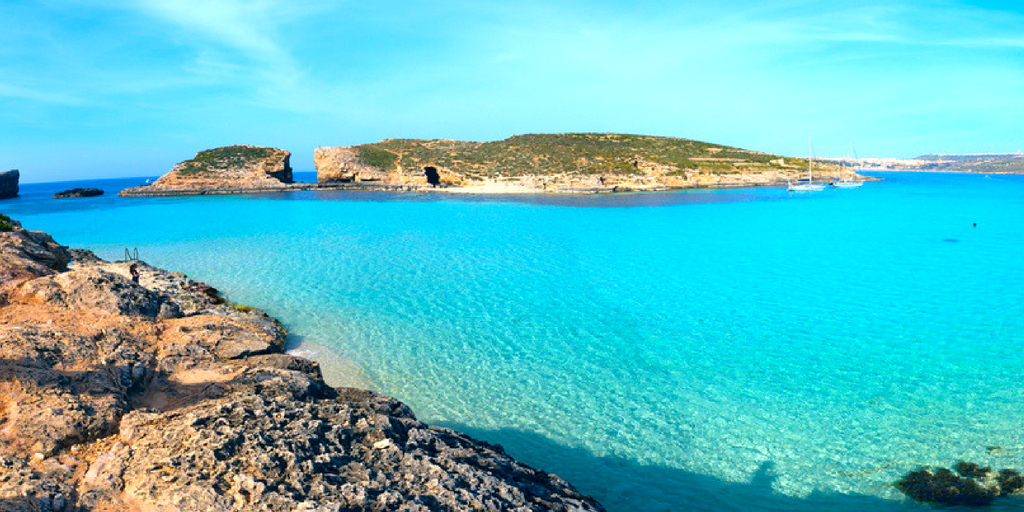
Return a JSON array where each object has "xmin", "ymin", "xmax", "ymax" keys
[{"xmin": 0, "ymin": 0, "xmax": 1024, "ymax": 182}]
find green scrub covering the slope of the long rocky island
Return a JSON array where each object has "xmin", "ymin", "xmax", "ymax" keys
[{"xmin": 355, "ymin": 133, "xmax": 807, "ymax": 177}]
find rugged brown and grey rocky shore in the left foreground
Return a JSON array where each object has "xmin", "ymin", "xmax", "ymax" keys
[{"xmin": 0, "ymin": 221, "xmax": 601, "ymax": 512}]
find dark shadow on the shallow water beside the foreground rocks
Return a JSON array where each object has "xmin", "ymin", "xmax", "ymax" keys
[{"xmin": 438, "ymin": 423, "xmax": 946, "ymax": 512}]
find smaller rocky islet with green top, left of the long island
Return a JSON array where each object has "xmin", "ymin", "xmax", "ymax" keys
[{"xmin": 120, "ymin": 145, "xmax": 302, "ymax": 196}]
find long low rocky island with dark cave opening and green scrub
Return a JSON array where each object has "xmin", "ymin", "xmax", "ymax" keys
[{"xmin": 314, "ymin": 133, "xmax": 850, "ymax": 193}]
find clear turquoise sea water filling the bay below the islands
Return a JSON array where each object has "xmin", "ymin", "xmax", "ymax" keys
[{"xmin": 8, "ymin": 173, "xmax": 1024, "ymax": 511}]
